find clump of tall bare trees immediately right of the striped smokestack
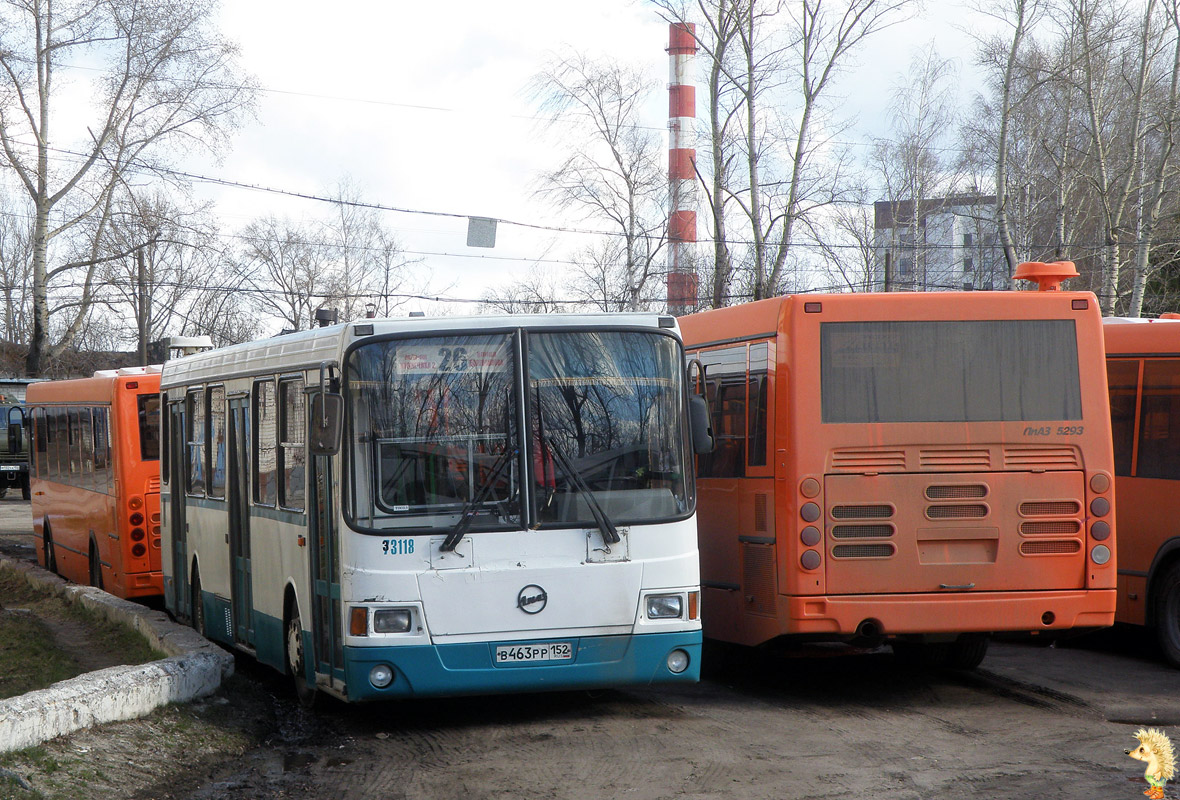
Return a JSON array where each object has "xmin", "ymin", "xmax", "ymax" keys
[{"xmin": 653, "ymin": 0, "xmax": 912, "ymax": 306}]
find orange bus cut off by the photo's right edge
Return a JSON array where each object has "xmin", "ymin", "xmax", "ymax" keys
[{"xmin": 1102, "ymin": 315, "xmax": 1180, "ymax": 667}]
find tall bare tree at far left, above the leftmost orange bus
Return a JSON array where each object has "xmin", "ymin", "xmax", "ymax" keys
[{"xmin": 0, "ymin": 0, "xmax": 251, "ymax": 375}]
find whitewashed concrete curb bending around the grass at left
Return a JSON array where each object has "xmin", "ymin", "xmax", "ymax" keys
[{"xmin": 0, "ymin": 556, "xmax": 234, "ymax": 753}]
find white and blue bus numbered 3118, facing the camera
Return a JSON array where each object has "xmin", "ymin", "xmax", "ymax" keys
[{"xmin": 160, "ymin": 314, "xmax": 709, "ymax": 702}]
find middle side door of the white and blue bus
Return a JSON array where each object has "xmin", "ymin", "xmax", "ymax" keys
[{"xmin": 225, "ymin": 395, "xmax": 254, "ymax": 647}]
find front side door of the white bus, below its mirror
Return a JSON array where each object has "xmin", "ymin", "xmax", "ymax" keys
[{"xmin": 308, "ymin": 455, "xmax": 345, "ymax": 688}]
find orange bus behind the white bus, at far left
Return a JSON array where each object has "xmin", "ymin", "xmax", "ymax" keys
[{"xmin": 25, "ymin": 367, "xmax": 163, "ymax": 598}]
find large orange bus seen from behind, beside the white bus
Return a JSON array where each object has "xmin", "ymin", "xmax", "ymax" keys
[{"xmin": 681, "ymin": 266, "xmax": 1116, "ymax": 668}]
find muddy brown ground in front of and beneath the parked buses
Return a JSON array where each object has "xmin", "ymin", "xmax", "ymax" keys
[{"xmin": 0, "ymin": 501, "xmax": 1180, "ymax": 800}]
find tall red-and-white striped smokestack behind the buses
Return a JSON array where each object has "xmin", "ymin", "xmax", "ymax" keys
[{"xmin": 668, "ymin": 22, "xmax": 696, "ymax": 314}]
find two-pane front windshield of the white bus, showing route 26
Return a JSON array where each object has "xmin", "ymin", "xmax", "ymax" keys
[{"xmin": 346, "ymin": 330, "xmax": 690, "ymax": 532}]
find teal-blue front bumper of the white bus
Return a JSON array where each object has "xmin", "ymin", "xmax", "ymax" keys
[{"xmin": 345, "ymin": 630, "xmax": 701, "ymax": 701}]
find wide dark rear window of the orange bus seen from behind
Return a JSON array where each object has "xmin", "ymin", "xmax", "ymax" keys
[{"xmin": 820, "ymin": 320, "xmax": 1082, "ymax": 422}]
